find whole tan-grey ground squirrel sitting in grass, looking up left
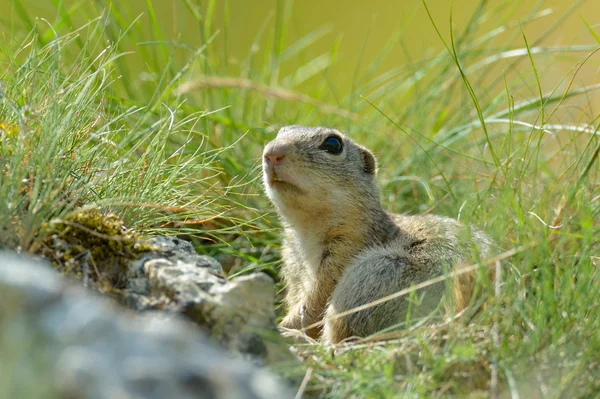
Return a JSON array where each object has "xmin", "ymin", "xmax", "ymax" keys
[{"xmin": 263, "ymin": 126, "xmax": 489, "ymax": 343}]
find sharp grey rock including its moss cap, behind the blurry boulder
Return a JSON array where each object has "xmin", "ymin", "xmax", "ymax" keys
[{"xmin": 41, "ymin": 214, "xmax": 295, "ymax": 364}]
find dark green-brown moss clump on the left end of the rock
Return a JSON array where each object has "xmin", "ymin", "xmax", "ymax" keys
[{"xmin": 41, "ymin": 209, "xmax": 152, "ymax": 292}]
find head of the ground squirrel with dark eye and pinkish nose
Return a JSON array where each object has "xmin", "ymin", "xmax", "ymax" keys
[{"xmin": 262, "ymin": 126, "xmax": 379, "ymax": 221}]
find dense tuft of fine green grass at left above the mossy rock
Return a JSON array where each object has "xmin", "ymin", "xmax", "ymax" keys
[{"xmin": 0, "ymin": 17, "xmax": 227, "ymax": 252}]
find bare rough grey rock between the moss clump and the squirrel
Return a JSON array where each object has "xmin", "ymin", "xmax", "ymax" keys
[{"xmin": 122, "ymin": 237, "xmax": 294, "ymax": 364}]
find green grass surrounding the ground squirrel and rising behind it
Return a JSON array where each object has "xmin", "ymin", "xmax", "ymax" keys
[{"xmin": 0, "ymin": 0, "xmax": 600, "ymax": 398}]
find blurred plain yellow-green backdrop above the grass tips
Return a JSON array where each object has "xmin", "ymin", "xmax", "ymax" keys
[{"xmin": 0, "ymin": 0, "xmax": 600, "ymax": 96}]
